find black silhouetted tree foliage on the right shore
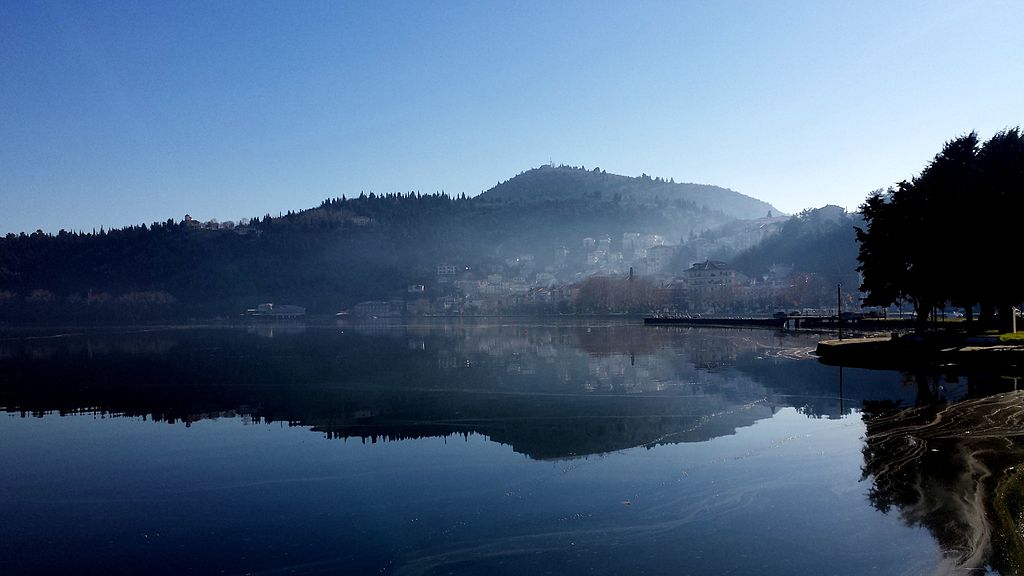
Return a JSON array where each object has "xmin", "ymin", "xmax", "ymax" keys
[{"xmin": 857, "ymin": 128, "xmax": 1024, "ymax": 327}]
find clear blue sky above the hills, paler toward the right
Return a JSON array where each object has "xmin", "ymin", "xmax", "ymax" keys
[{"xmin": 0, "ymin": 0, "xmax": 1024, "ymax": 234}]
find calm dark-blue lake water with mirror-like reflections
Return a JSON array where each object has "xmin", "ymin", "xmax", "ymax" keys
[{"xmin": 0, "ymin": 322, "xmax": 1024, "ymax": 575}]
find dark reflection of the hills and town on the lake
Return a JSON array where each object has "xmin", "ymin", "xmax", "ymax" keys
[{"xmin": 0, "ymin": 323, "xmax": 885, "ymax": 459}]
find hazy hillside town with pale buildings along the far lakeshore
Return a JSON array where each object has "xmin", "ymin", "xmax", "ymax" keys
[{"xmin": 348, "ymin": 214, "xmax": 859, "ymax": 318}]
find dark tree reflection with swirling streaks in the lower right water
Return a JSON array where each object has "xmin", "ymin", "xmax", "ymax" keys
[{"xmin": 863, "ymin": 378, "xmax": 1024, "ymax": 574}]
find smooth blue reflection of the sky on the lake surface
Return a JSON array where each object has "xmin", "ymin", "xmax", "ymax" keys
[{"xmin": 0, "ymin": 409, "xmax": 937, "ymax": 574}]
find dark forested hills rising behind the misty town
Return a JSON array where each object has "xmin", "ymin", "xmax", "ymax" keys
[{"xmin": 0, "ymin": 166, "xmax": 777, "ymax": 321}]
